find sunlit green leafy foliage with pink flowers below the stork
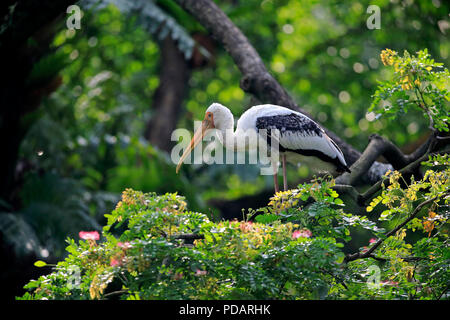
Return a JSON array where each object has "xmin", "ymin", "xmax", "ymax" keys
[{"xmin": 22, "ymin": 157, "xmax": 450, "ymax": 299}]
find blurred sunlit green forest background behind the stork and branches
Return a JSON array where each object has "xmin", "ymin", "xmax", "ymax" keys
[{"xmin": 0, "ymin": 0, "xmax": 450, "ymax": 298}]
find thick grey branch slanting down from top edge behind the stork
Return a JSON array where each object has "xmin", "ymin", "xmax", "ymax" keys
[{"xmin": 176, "ymin": 0, "xmax": 387, "ymax": 183}]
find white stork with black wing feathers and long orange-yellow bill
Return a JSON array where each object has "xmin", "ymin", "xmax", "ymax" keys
[{"xmin": 176, "ymin": 103, "xmax": 350, "ymax": 192}]
